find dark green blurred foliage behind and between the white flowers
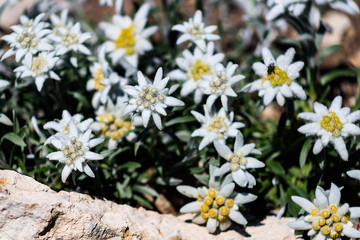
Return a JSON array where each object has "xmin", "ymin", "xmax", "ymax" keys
[{"xmin": 0, "ymin": 0, "xmax": 360, "ymax": 223}]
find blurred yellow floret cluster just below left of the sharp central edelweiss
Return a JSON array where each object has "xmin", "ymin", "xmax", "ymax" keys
[{"xmin": 98, "ymin": 114, "xmax": 131, "ymax": 140}]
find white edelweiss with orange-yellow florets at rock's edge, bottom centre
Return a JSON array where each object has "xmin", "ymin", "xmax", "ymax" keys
[{"xmin": 176, "ymin": 167, "xmax": 256, "ymax": 233}]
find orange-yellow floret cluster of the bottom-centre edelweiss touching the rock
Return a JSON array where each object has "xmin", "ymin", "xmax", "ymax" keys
[{"xmin": 199, "ymin": 189, "xmax": 234, "ymax": 222}]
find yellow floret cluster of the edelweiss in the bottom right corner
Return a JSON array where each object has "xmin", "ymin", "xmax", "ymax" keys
[{"xmin": 310, "ymin": 205, "xmax": 349, "ymax": 238}]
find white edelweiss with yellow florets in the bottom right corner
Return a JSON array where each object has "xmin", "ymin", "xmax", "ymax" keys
[{"xmin": 288, "ymin": 183, "xmax": 360, "ymax": 240}]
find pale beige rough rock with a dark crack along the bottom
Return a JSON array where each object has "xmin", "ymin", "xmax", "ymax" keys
[{"xmin": 0, "ymin": 170, "xmax": 295, "ymax": 240}]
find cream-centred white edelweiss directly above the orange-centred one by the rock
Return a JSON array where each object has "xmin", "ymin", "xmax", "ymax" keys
[{"xmin": 214, "ymin": 132, "xmax": 265, "ymax": 188}]
